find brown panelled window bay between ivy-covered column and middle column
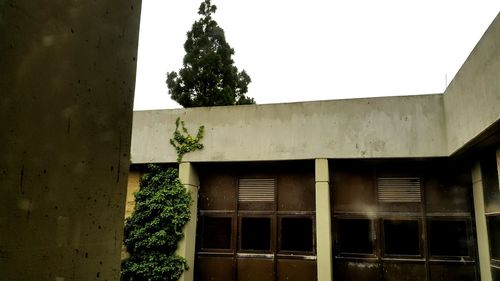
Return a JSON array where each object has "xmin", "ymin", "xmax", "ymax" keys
[{"xmin": 195, "ymin": 163, "xmax": 317, "ymax": 281}]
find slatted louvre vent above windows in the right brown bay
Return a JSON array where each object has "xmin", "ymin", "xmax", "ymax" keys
[{"xmin": 377, "ymin": 178, "xmax": 421, "ymax": 203}]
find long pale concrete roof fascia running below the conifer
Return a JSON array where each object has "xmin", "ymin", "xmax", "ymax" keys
[{"xmin": 131, "ymin": 95, "xmax": 447, "ymax": 163}]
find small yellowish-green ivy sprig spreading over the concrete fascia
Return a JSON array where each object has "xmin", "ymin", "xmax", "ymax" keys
[{"xmin": 170, "ymin": 117, "xmax": 205, "ymax": 163}]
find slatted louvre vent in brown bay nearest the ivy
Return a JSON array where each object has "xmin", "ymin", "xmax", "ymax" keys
[{"xmin": 238, "ymin": 178, "xmax": 276, "ymax": 202}]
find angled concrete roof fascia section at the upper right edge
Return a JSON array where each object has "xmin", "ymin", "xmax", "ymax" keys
[{"xmin": 444, "ymin": 12, "xmax": 500, "ymax": 154}]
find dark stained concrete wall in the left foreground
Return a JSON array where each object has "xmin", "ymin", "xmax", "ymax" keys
[{"xmin": 0, "ymin": 0, "xmax": 140, "ymax": 281}]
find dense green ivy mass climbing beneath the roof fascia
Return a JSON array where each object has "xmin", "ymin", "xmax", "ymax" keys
[{"xmin": 121, "ymin": 165, "xmax": 192, "ymax": 281}]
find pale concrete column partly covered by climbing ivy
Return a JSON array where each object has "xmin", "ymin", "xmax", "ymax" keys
[{"xmin": 177, "ymin": 162, "xmax": 200, "ymax": 281}]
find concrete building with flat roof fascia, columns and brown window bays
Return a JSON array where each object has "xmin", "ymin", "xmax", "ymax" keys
[{"xmin": 129, "ymin": 12, "xmax": 500, "ymax": 281}]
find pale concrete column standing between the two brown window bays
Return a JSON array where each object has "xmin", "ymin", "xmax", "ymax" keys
[{"xmin": 315, "ymin": 159, "xmax": 332, "ymax": 281}]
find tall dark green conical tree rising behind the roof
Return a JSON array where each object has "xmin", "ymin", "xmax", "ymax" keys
[{"xmin": 167, "ymin": 0, "xmax": 255, "ymax": 107}]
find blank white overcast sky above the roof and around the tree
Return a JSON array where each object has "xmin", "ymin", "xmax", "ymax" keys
[{"xmin": 134, "ymin": 0, "xmax": 500, "ymax": 110}]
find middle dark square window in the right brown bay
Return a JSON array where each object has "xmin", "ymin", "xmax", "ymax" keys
[{"xmin": 384, "ymin": 220, "xmax": 420, "ymax": 256}]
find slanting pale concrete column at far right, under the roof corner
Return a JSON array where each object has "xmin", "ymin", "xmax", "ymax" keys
[{"xmin": 472, "ymin": 162, "xmax": 492, "ymax": 281}]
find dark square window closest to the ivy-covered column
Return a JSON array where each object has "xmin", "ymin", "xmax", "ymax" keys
[{"xmin": 201, "ymin": 217, "xmax": 231, "ymax": 249}]
